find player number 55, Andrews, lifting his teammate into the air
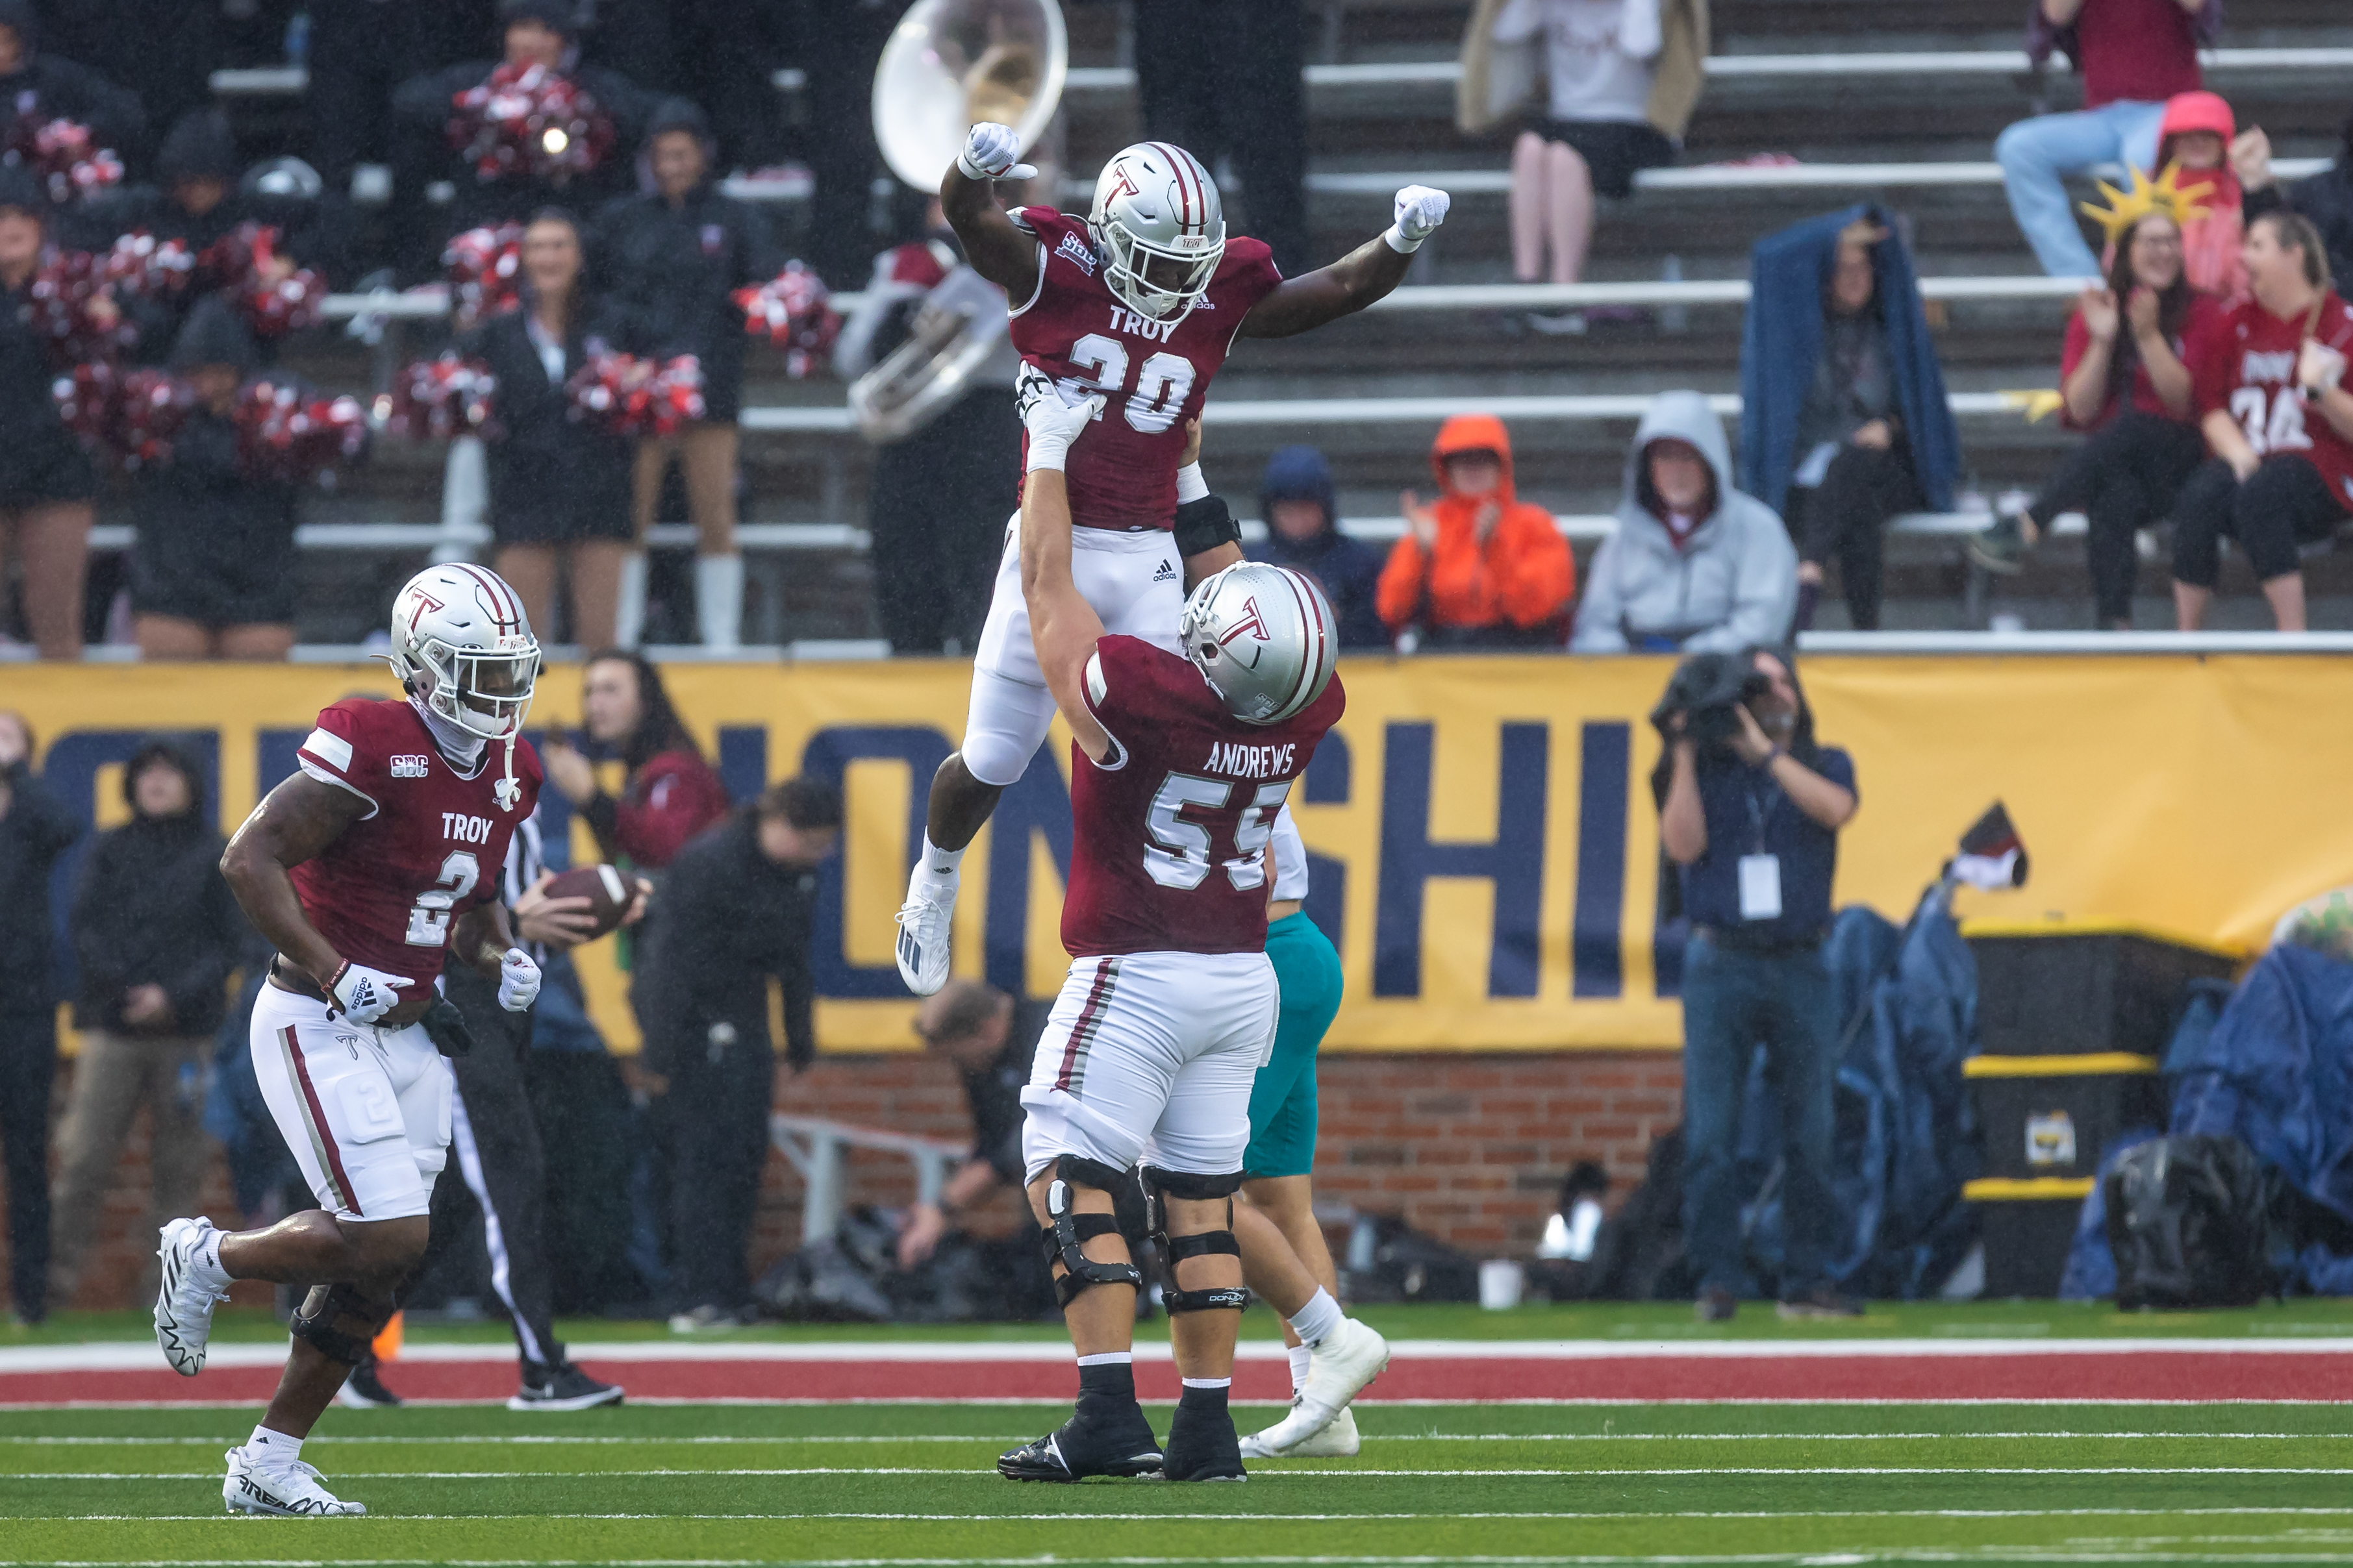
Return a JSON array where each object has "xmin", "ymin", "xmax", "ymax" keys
[{"xmin": 998, "ymin": 369, "xmax": 1386, "ymax": 1481}]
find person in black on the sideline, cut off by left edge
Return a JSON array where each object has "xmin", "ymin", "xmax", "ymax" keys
[{"xmin": 0, "ymin": 710, "xmax": 82, "ymax": 1326}]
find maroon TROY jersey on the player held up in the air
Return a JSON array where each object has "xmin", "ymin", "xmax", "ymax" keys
[{"xmin": 1012, "ymin": 207, "xmax": 1283, "ymax": 529}]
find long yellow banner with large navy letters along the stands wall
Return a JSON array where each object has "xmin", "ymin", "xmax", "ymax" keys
[{"xmin": 14, "ymin": 656, "xmax": 2353, "ymax": 1051}]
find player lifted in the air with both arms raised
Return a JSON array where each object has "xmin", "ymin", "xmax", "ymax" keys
[{"xmin": 899, "ymin": 122, "xmax": 1447, "ymax": 997}]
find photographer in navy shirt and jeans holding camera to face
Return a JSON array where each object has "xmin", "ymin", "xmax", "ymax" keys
[{"xmin": 1652, "ymin": 649, "xmax": 1859, "ymax": 1323}]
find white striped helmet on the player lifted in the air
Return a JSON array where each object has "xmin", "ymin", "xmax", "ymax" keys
[{"xmin": 1087, "ymin": 141, "xmax": 1226, "ymax": 322}]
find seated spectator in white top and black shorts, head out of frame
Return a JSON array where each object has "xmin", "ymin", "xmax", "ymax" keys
[{"xmin": 1454, "ymin": 0, "xmax": 1708, "ymax": 332}]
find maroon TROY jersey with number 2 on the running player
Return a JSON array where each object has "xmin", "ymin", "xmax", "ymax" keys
[{"xmin": 294, "ymin": 698, "xmax": 541, "ymax": 988}]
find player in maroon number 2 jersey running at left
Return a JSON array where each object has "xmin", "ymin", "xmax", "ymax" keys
[{"xmin": 155, "ymin": 564, "xmax": 539, "ymax": 1514}]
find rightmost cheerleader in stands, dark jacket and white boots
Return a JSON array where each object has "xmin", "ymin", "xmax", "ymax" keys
[{"xmin": 596, "ymin": 99, "xmax": 783, "ymax": 649}]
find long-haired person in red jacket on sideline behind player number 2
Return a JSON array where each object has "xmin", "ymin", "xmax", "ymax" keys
[{"xmin": 544, "ymin": 649, "xmax": 727, "ymax": 870}]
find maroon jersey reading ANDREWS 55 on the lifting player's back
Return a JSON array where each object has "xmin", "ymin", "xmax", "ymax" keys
[{"xmin": 1061, "ymin": 637, "xmax": 1346, "ymax": 959}]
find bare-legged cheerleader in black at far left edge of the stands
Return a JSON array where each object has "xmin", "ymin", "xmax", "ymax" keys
[{"xmin": 0, "ymin": 169, "xmax": 99, "ymax": 658}]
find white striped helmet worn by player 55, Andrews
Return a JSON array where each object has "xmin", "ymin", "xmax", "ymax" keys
[{"xmin": 1177, "ymin": 562, "xmax": 1339, "ymax": 724}]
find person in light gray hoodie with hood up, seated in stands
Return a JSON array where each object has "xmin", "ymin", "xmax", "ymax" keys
[{"xmin": 1570, "ymin": 393, "xmax": 1798, "ymax": 654}]
